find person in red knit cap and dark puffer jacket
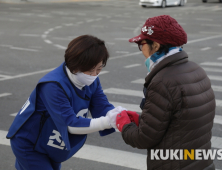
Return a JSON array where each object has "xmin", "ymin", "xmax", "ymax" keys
[{"xmin": 117, "ymin": 15, "xmax": 215, "ymax": 170}]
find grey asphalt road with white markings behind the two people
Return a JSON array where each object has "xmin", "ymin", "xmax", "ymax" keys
[{"xmin": 0, "ymin": 0, "xmax": 222, "ymax": 170}]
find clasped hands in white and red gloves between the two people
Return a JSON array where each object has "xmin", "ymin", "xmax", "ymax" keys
[{"xmin": 106, "ymin": 106, "xmax": 139, "ymax": 132}]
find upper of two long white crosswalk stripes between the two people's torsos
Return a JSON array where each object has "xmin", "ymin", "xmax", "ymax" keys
[{"xmin": 104, "ymin": 88, "xmax": 144, "ymax": 97}]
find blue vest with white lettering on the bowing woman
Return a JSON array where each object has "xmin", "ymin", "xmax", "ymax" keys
[{"xmin": 6, "ymin": 63, "xmax": 115, "ymax": 162}]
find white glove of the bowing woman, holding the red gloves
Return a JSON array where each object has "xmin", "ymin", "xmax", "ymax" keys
[{"xmin": 106, "ymin": 106, "xmax": 127, "ymax": 129}]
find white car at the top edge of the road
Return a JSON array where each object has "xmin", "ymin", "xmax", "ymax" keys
[{"xmin": 139, "ymin": 0, "xmax": 186, "ymax": 8}]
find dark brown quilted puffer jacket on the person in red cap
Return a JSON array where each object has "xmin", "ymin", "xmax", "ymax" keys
[{"xmin": 122, "ymin": 51, "xmax": 216, "ymax": 170}]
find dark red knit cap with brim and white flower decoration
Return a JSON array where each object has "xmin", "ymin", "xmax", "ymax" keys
[{"xmin": 129, "ymin": 15, "xmax": 187, "ymax": 46}]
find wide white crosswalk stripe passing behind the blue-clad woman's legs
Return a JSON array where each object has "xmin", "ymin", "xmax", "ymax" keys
[{"xmin": 0, "ymin": 130, "xmax": 147, "ymax": 170}]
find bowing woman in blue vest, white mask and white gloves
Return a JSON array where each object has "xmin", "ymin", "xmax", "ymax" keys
[{"xmin": 7, "ymin": 35, "xmax": 124, "ymax": 170}]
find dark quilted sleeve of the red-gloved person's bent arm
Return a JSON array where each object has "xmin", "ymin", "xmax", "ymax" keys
[{"xmin": 122, "ymin": 81, "xmax": 172, "ymax": 149}]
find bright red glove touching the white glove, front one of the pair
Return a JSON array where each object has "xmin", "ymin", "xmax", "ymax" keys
[{"xmin": 116, "ymin": 110, "xmax": 131, "ymax": 132}]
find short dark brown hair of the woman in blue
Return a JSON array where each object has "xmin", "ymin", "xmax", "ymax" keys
[{"xmin": 64, "ymin": 35, "xmax": 109, "ymax": 73}]
